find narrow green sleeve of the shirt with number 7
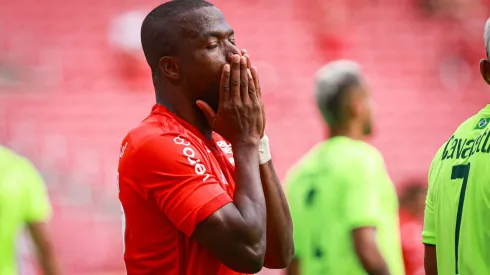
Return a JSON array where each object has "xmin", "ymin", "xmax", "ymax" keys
[{"xmin": 422, "ymin": 149, "xmax": 444, "ymax": 245}]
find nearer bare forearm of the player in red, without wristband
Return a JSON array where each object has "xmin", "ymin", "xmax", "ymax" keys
[{"xmin": 233, "ymin": 141, "xmax": 266, "ymax": 247}]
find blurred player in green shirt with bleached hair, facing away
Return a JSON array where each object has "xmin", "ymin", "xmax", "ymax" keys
[{"xmin": 286, "ymin": 61, "xmax": 404, "ymax": 275}]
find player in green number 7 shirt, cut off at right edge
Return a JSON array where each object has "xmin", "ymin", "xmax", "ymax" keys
[{"xmin": 422, "ymin": 17, "xmax": 490, "ymax": 275}]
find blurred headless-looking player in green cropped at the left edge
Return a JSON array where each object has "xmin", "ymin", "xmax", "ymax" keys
[{"xmin": 0, "ymin": 146, "xmax": 60, "ymax": 275}]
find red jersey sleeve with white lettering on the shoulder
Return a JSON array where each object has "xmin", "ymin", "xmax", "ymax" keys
[{"xmin": 134, "ymin": 134, "xmax": 232, "ymax": 236}]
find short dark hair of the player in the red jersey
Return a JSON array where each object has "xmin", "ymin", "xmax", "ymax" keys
[{"xmin": 141, "ymin": 0, "xmax": 214, "ymax": 72}]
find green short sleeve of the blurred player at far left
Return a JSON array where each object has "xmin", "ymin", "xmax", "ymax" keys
[{"xmin": 19, "ymin": 160, "xmax": 51, "ymax": 223}]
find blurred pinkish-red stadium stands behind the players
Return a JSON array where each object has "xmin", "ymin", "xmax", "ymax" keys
[{"xmin": 0, "ymin": 0, "xmax": 490, "ymax": 275}]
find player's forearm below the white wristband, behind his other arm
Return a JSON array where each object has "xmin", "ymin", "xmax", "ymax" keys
[{"xmin": 260, "ymin": 161, "xmax": 294, "ymax": 268}]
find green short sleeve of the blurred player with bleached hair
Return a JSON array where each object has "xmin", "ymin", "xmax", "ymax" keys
[{"xmin": 344, "ymin": 155, "xmax": 380, "ymax": 229}]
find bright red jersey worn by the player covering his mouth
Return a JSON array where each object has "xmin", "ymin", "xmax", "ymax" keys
[{"xmin": 118, "ymin": 105, "xmax": 245, "ymax": 275}]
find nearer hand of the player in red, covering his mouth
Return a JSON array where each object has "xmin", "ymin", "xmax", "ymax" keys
[{"xmin": 196, "ymin": 55, "xmax": 264, "ymax": 145}]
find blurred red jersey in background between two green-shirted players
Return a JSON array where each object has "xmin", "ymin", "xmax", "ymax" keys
[{"xmin": 400, "ymin": 210, "xmax": 425, "ymax": 275}]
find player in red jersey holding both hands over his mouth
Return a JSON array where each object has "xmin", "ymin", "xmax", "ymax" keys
[{"xmin": 118, "ymin": 0, "xmax": 294, "ymax": 275}]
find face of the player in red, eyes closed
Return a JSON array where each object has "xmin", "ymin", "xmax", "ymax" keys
[{"xmin": 180, "ymin": 7, "xmax": 240, "ymax": 111}]
